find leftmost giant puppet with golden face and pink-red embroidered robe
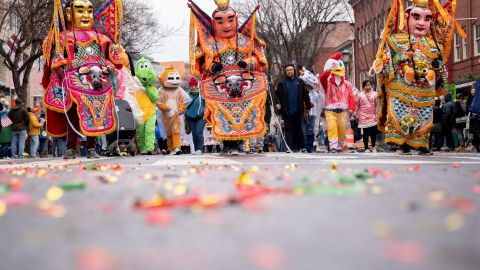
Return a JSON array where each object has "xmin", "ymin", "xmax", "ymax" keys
[{"xmin": 42, "ymin": 0, "xmax": 128, "ymax": 158}]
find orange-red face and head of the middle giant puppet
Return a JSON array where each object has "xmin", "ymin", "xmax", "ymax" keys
[{"xmin": 212, "ymin": 0, "xmax": 238, "ymax": 38}]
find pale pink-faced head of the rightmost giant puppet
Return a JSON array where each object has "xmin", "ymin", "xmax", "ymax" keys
[{"xmin": 405, "ymin": 0, "xmax": 433, "ymax": 37}]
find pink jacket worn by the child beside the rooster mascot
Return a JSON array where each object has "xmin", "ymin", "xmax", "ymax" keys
[{"xmin": 354, "ymin": 90, "xmax": 377, "ymax": 128}]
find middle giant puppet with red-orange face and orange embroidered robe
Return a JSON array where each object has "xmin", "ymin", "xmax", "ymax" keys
[{"xmin": 189, "ymin": 0, "xmax": 268, "ymax": 153}]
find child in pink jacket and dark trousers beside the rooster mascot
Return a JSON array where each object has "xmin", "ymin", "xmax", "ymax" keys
[{"xmin": 355, "ymin": 80, "xmax": 378, "ymax": 152}]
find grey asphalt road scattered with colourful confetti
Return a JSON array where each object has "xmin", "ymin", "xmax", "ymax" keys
[{"xmin": 0, "ymin": 153, "xmax": 480, "ymax": 270}]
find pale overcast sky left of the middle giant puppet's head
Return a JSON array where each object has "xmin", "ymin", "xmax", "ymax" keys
[{"xmin": 147, "ymin": 0, "xmax": 216, "ymax": 62}]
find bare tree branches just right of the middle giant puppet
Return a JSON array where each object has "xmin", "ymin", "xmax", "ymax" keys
[{"xmin": 234, "ymin": 0, "xmax": 344, "ymax": 80}]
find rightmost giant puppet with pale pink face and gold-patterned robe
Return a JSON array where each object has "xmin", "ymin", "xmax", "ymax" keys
[{"xmin": 370, "ymin": 0, "xmax": 465, "ymax": 154}]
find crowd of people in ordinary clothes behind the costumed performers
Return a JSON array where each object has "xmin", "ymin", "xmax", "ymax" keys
[{"xmin": 0, "ymin": 73, "xmax": 480, "ymax": 159}]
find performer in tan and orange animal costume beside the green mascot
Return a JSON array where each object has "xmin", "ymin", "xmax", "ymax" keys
[{"xmin": 157, "ymin": 66, "xmax": 187, "ymax": 155}]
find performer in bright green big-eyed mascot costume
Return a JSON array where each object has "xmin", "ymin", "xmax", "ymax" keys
[{"xmin": 135, "ymin": 57, "xmax": 158, "ymax": 154}]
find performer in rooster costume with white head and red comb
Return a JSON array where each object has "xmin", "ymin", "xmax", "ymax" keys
[{"xmin": 320, "ymin": 52, "xmax": 355, "ymax": 153}]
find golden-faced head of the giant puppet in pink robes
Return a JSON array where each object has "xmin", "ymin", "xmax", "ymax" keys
[{"xmin": 65, "ymin": 0, "xmax": 94, "ymax": 30}]
